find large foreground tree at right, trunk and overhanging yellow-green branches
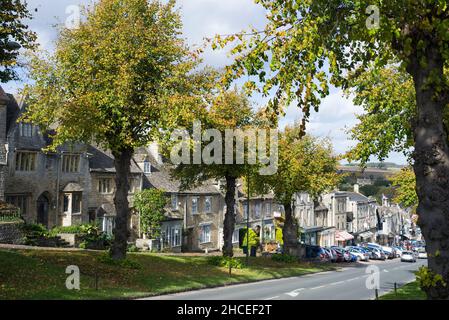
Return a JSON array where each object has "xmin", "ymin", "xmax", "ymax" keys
[{"xmin": 215, "ymin": 0, "xmax": 449, "ymax": 299}]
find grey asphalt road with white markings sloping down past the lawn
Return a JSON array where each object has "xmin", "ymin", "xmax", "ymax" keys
[{"xmin": 147, "ymin": 259, "xmax": 427, "ymax": 300}]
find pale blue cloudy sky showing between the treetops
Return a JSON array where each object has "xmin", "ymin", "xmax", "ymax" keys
[{"xmin": 2, "ymin": 0, "xmax": 406, "ymax": 164}]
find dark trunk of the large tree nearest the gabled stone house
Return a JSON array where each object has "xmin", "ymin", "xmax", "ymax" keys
[{"xmin": 111, "ymin": 149, "xmax": 133, "ymax": 260}]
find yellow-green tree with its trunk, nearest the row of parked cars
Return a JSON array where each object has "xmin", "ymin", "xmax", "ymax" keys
[{"xmin": 248, "ymin": 126, "xmax": 340, "ymax": 253}]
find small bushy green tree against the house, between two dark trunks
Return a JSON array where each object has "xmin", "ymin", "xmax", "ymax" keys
[{"xmin": 134, "ymin": 188, "xmax": 168, "ymax": 238}]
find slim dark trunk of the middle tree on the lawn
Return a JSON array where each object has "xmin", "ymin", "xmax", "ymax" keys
[{"xmin": 223, "ymin": 176, "xmax": 236, "ymax": 257}]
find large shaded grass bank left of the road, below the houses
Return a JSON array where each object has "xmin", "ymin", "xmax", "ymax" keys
[{"xmin": 0, "ymin": 250, "xmax": 333, "ymax": 299}]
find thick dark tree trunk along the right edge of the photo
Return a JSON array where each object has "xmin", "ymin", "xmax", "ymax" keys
[{"xmin": 408, "ymin": 45, "xmax": 449, "ymax": 299}]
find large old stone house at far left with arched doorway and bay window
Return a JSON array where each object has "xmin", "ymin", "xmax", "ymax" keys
[{"xmin": 2, "ymin": 94, "xmax": 142, "ymax": 233}]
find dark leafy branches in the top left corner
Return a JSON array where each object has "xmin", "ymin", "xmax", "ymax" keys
[{"xmin": 0, "ymin": 0, "xmax": 36, "ymax": 82}]
